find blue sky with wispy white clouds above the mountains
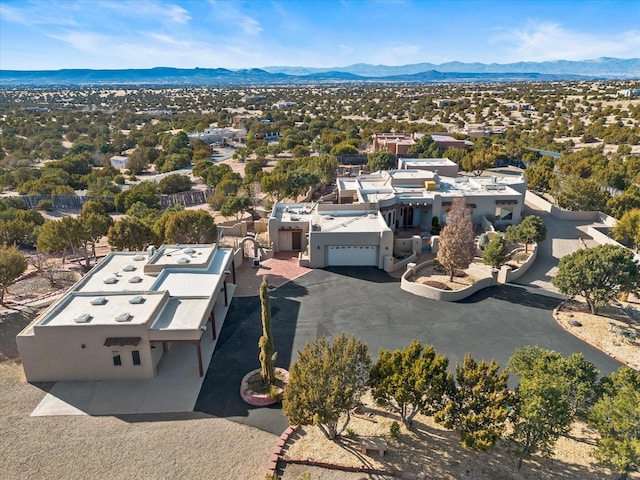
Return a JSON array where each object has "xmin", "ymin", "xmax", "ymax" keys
[{"xmin": 0, "ymin": 0, "xmax": 640, "ymax": 70}]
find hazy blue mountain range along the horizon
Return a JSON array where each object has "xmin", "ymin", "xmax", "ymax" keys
[{"xmin": 0, "ymin": 58, "xmax": 640, "ymax": 88}]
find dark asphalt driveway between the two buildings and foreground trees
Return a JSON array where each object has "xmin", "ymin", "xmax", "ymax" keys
[{"xmin": 195, "ymin": 267, "xmax": 620, "ymax": 435}]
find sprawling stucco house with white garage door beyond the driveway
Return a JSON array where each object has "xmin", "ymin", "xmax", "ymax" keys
[{"xmin": 268, "ymin": 169, "xmax": 526, "ymax": 269}]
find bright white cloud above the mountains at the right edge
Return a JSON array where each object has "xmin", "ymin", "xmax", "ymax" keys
[{"xmin": 491, "ymin": 20, "xmax": 640, "ymax": 63}]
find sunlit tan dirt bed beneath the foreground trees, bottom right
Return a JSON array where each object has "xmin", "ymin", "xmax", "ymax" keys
[{"xmin": 282, "ymin": 397, "xmax": 640, "ymax": 480}]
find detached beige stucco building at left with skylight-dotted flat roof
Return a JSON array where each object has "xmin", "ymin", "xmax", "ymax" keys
[{"xmin": 16, "ymin": 244, "xmax": 235, "ymax": 382}]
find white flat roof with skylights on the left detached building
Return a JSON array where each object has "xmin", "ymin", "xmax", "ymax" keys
[{"xmin": 33, "ymin": 244, "xmax": 233, "ymax": 339}]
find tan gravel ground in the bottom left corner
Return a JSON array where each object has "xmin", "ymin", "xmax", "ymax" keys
[{"xmin": 0, "ymin": 313, "xmax": 277, "ymax": 480}]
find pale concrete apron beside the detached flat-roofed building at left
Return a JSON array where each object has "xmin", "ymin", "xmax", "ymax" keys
[{"xmin": 31, "ymin": 284, "xmax": 235, "ymax": 416}]
